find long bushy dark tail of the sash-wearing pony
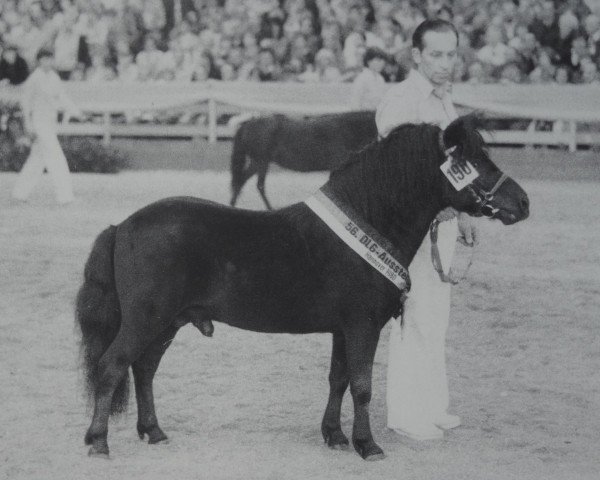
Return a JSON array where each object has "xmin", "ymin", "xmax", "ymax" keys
[{"xmin": 75, "ymin": 225, "xmax": 129, "ymax": 414}]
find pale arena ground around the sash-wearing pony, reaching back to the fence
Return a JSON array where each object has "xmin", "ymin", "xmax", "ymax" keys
[{"xmin": 0, "ymin": 142, "xmax": 600, "ymax": 480}]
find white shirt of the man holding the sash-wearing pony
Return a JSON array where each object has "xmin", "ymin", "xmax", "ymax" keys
[{"xmin": 375, "ymin": 70, "xmax": 458, "ymax": 137}]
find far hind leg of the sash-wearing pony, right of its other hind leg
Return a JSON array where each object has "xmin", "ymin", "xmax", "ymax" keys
[{"xmin": 132, "ymin": 326, "xmax": 178, "ymax": 444}]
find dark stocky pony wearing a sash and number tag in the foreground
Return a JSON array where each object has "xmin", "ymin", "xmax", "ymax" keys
[{"xmin": 76, "ymin": 118, "xmax": 528, "ymax": 459}]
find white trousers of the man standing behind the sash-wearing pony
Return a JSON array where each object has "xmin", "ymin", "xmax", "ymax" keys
[{"xmin": 386, "ymin": 219, "xmax": 458, "ymax": 430}]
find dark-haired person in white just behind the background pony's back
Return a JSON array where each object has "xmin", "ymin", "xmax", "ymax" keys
[{"xmin": 350, "ymin": 48, "xmax": 387, "ymax": 110}]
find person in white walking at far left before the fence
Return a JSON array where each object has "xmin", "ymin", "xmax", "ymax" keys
[{"xmin": 12, "ymin": 49, "xmax": 79, "ymax": 204}]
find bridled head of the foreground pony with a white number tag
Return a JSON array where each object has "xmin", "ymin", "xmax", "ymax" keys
[{"xmin": 439, "ymin": 115, "xmax": 529, "ymax": 225}]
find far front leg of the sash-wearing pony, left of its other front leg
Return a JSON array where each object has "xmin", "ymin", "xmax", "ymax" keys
[{"xmin": 321, "ymin": 332, "xmax": 350, "ymax": 449}]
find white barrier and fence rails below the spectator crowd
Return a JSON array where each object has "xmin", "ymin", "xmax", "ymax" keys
[{"xmin": 0, "ymin": 81, "xmax": 600, "ymax": 150}]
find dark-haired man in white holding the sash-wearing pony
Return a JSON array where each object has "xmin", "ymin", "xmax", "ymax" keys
[{"xmin": 376, "ymin": 20, "xmax": 475, "ymax": 440}]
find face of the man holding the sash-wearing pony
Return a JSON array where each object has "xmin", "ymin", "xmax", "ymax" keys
[{"xmin": 412, "ymin": 31, "xmax": 458, "ymax": 86}]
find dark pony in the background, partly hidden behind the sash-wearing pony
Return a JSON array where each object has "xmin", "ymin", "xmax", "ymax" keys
[{"xmin": 230, "ymin": 111, "xmax": 377, "ymax": 210}]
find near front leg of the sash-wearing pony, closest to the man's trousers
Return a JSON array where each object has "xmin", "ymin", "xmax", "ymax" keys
[{"xmin": 346, "ymin": 320, "xmax": 384, "ymax": 460}]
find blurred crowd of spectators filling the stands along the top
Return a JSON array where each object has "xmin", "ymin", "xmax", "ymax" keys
[{"xmin": 0, "ymin": 0, "xmax": 600, "ymax": 84}]
